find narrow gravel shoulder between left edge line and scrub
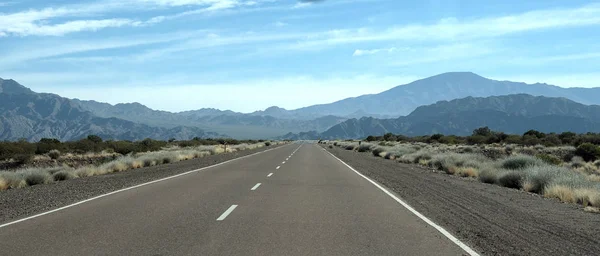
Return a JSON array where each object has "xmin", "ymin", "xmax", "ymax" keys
[{"xmin": 0, "ymin": 144, "xmax": 285, "ymax": 224}]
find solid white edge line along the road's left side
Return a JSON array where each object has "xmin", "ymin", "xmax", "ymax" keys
[{"xmin": 0, "ymin": 143, "xmax": 285, "ymax": 228}]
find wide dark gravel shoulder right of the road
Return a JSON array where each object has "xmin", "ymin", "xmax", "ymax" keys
[{"xmin": 327, "ymin": 147, "xmax": 600, "ymax": 255}]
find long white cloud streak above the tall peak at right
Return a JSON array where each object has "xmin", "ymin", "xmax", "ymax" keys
[{"xmin": 290, "ymin": 4, "xmax": 600, "ymax": 49}]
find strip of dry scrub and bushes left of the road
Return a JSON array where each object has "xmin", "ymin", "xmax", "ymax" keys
[{"xmin": 0, "ymin": 136, "xmax": 284, "ymax": 191}]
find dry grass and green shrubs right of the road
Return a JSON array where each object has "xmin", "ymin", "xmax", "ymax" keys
[{"xmin": 321, "ymin": 127, "xmax": 600, "ymax": 211}]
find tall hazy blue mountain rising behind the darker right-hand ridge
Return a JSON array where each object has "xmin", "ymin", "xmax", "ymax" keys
[{"xmin": 252, "ymin": 72, "xmax": 600, "ymax": 118}]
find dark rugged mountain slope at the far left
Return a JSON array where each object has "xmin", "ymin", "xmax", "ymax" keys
[{"xmin": 0, "ymin": 79, "xmax": 225, "ymax": 141}]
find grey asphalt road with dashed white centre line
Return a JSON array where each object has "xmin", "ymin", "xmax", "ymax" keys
[{"xmin": 0, "ymin": 144, "xmax": 474, "ymax": 255}]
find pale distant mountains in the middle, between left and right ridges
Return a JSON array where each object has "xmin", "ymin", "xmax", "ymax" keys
[{"xmin": 73, "ymin": 99, "xmax": 348, "ymax": 139}]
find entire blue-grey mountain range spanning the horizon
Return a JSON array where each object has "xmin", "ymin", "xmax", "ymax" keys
[{"xmin": 0, "ymin": 72, "xmax": 600, "ymax": 140}]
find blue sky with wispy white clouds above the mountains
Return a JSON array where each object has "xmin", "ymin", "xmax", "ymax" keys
[{"xmin": 0, "ymin": 0, "xmax": 600, "ymax": 112}]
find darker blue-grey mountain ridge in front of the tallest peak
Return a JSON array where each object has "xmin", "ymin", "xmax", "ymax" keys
[{"xmin": 284, "ymin": 94, "xmax": 600, "ymax": 139}]
